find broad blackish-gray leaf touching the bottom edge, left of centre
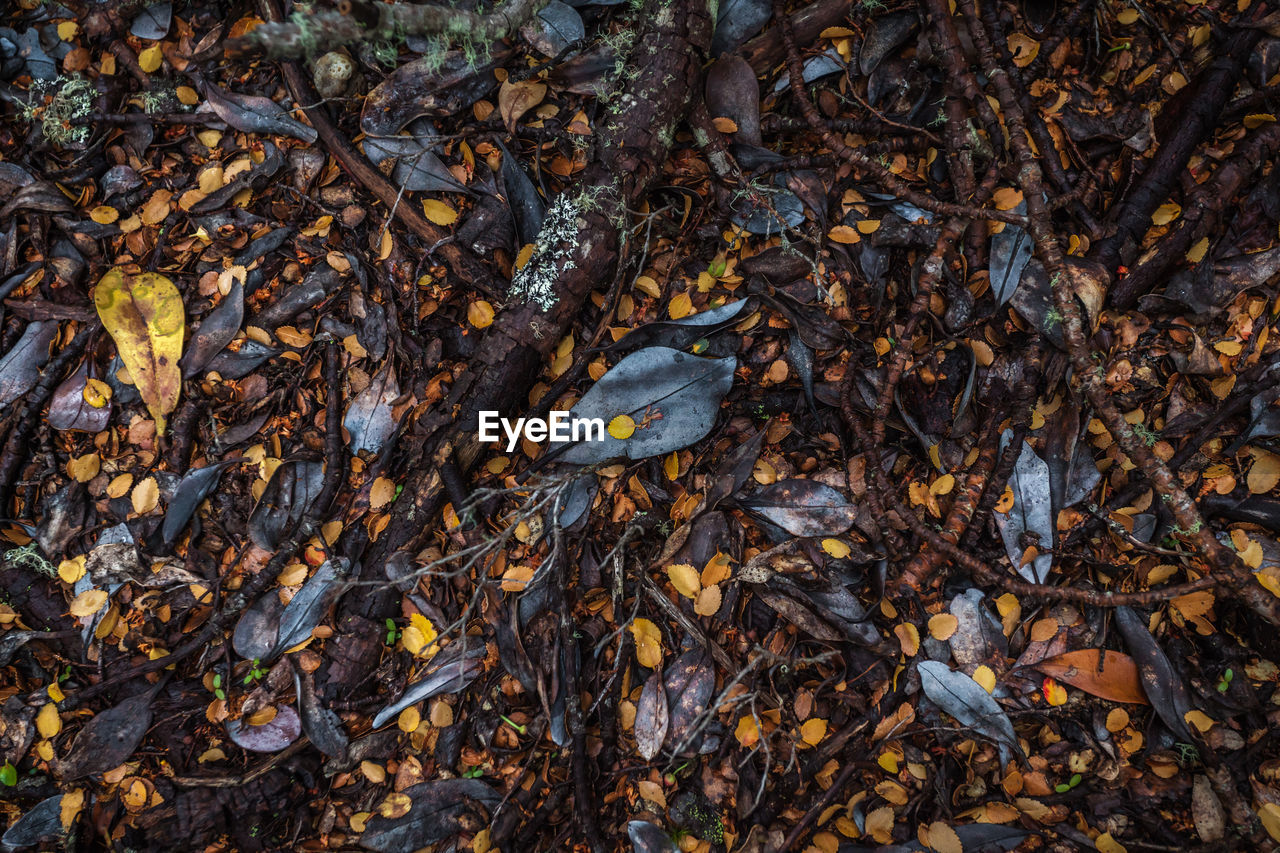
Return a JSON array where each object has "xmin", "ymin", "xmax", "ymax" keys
[{"xmin": 360, "ymin": 779, "xmax": 502, "ymax": 853}]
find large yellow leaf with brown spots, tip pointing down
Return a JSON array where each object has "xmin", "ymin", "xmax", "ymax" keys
[{"xmin": 93, "ymin": 269, "xmax": 187, "ymax": 433}]
